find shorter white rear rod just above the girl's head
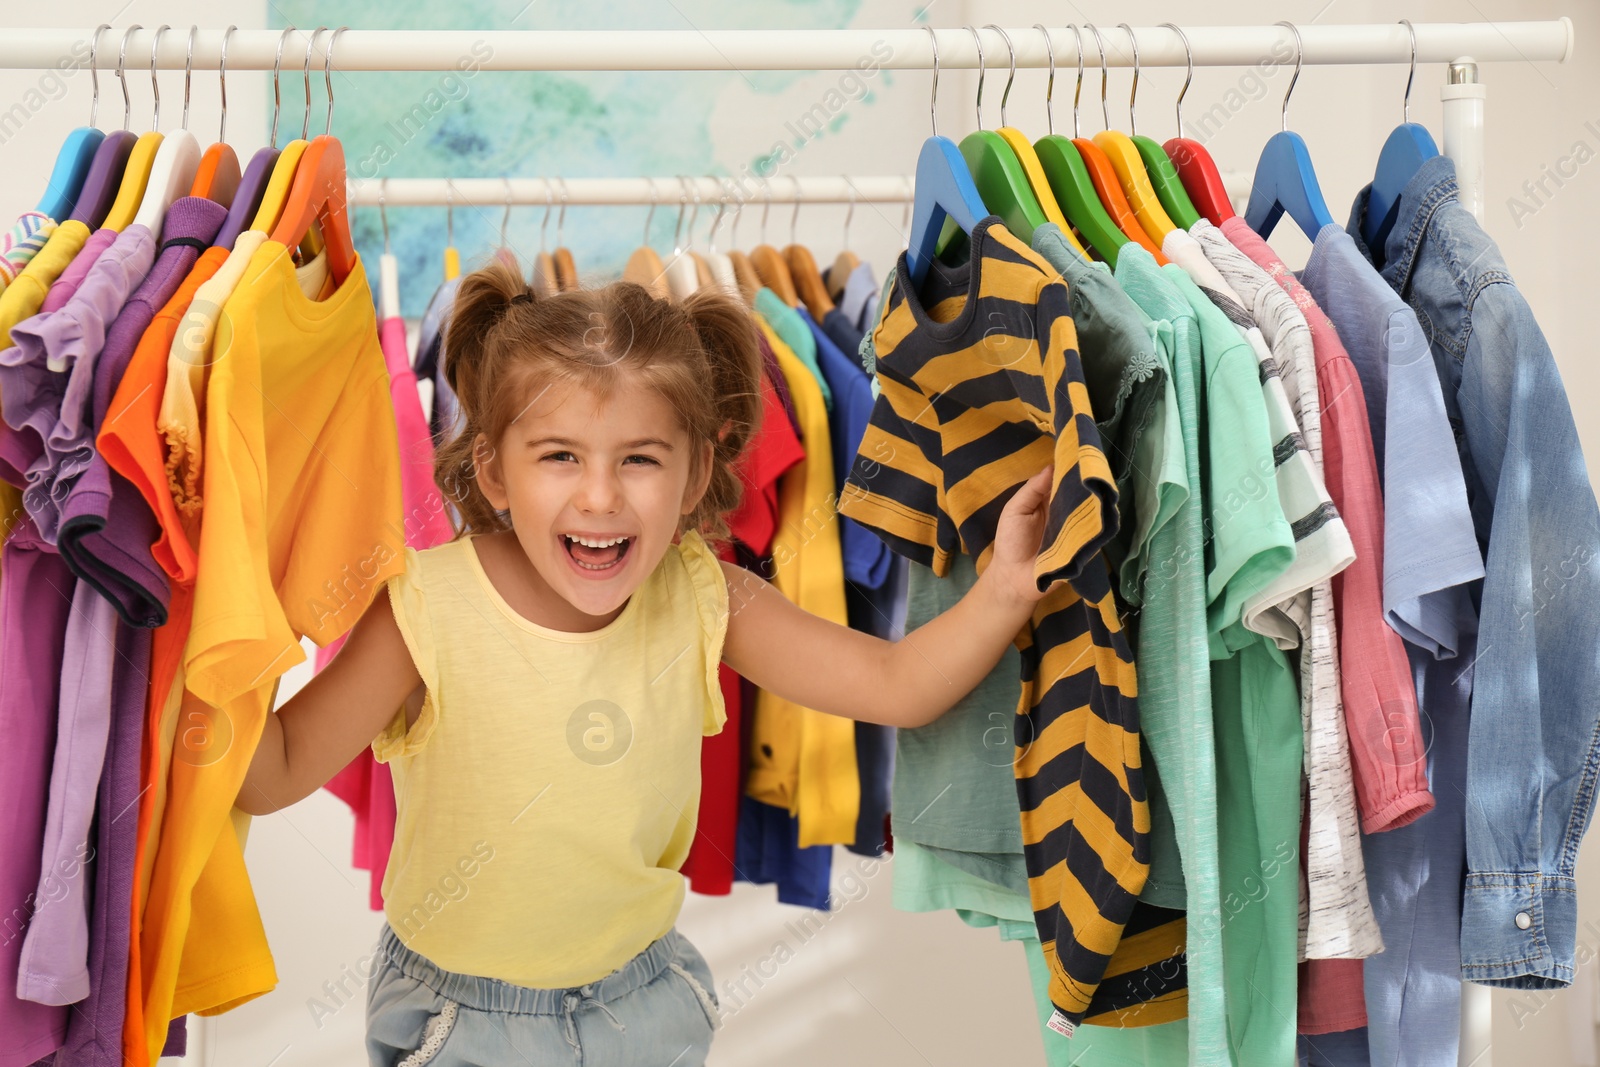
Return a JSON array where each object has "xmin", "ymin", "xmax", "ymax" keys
[{"xmin": 349, "ymin": 174, "xmax": 915, "ymax": 208}]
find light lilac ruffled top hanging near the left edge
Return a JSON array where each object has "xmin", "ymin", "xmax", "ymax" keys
[{"xmin": 0, "ymin": 222, "xmax": 155, "ymax": 544}]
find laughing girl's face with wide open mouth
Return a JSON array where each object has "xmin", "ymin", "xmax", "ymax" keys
[{"xmin": 478, "ymin": 376, "xmax": 710, "ymax": 616}]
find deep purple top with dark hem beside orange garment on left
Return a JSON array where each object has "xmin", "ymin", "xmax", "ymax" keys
[{"xmin": 58, "ymin": 197, "xmax": 227, "ymax": 627}]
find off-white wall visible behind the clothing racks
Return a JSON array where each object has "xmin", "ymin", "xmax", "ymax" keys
[{"xmin": 0, "ymin": 0, "xmax": 1600, "ymax": 1067}]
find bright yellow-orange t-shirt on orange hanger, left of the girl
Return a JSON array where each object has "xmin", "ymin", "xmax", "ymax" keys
[{"xmin": 141, "ymin": 242, "xmax": 405, "ymax": 1062}]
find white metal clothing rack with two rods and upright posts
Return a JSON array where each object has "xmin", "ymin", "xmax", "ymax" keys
[{"xmin": 9, "ymin": 18, "xmax": 1576, "ymax": 1067}]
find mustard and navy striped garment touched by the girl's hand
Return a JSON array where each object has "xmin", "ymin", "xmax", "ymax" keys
[{"xmin": 838, "ymin": 218, "xmax": 1164, "ymax": 1032}]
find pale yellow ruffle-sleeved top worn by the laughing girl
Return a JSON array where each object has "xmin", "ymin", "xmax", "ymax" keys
[{"xmin": 373, "ymin": 531, "xmax": 728, "ymax": 989}]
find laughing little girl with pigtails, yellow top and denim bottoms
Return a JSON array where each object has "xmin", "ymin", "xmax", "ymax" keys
[{"xmin": 237, "ymin": 262, "xmax": 1050, "ymax": 1067}]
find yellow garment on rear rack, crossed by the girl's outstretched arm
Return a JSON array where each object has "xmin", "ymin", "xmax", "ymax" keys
[{"xmin": 744, "ymin": 318, "xmax": 861, "ymax": 846}]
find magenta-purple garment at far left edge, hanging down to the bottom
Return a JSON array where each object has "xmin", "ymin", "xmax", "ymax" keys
[{"xmin": 0, "ymin": 515, "xmax": 74, "ymax": 1067}]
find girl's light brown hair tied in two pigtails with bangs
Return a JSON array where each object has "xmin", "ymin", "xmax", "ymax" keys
[{"xmin": 434, "ymin": 258, "xmax": 762, "ymax": 541}]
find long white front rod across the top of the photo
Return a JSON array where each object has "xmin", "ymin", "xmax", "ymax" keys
[{"xmin": 0, "ymin": 16, "xmax": 1574, "ymax": 75}]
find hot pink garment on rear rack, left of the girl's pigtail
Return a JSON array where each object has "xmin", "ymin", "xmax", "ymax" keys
[{"xmin": 317, "ymin": 317, "xmax": 454, "ymax": 910}]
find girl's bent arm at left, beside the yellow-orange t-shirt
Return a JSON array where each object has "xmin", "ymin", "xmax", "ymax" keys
[{"xmin": 234, "ymin": 587, "xmax": 422, "ymax": 816}]
